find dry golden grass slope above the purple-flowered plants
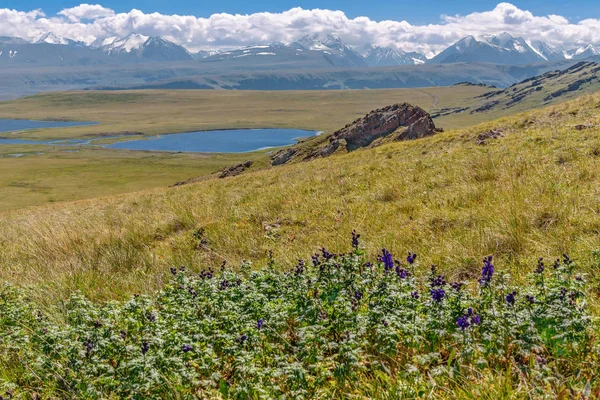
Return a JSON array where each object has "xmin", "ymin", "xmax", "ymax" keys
[{"xmin": 0, "ymin": 91, "xmax": 600, "ymax": 299}]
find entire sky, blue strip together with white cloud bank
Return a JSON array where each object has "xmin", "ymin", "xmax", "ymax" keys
[{"xmin": 0, "ymin": 0, "xmax": 600, "ymax": 55}]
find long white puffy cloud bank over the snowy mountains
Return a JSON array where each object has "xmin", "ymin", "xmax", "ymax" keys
[{"xmin": 0, "ymin": 3, "xmax": 600, "ymax": 54}]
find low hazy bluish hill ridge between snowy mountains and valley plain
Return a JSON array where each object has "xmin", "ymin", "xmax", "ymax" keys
[{"xmin": 88, "ymin": 60, "xmax": 575, "ymax": 94}]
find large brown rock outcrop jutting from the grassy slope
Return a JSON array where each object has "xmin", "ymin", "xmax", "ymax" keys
[{"xmin": 272, "ymin": 103, "xmax": 441, "ymax": 165}]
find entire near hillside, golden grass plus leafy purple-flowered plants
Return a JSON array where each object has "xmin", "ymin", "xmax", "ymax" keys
[{"xmin": 0, "ymin": 84, "xmax": 600, "ymax": 399}]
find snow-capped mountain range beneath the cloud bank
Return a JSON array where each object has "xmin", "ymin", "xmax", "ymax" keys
[{"xmin": 0, "ymin": 32, "xmax": 600, "ymax": 68}]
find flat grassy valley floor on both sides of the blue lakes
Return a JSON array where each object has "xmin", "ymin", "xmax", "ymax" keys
[{"xmin": 0, "ymin": 87, "xmax": 485, "ymax": 210}]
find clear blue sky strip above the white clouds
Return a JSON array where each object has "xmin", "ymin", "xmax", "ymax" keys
[{"xmin": 8, "ymin": 0, "xmax": 600, "ymax": 24}]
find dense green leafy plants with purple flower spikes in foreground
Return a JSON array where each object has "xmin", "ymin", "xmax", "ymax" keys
[{"xmin": 0, "ymin": 234, "xmax": 599, "ymax": 399}]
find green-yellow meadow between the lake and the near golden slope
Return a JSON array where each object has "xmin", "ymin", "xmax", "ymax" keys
[{"xmin": 0, "ymin": 145, "xmax": 268, "ymax": 210}]
